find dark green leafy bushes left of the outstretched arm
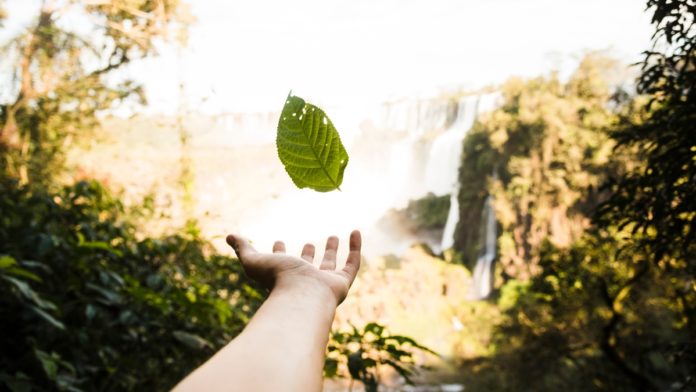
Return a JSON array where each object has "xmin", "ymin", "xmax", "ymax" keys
[{"xmin": 0, "ymin": 178, "xmax": 262, "ymax": 391}]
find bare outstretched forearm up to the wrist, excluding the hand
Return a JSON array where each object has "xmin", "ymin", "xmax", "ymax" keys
[{"xmin": 176, "ymin": 278, "xmax": 336, "ymax": 392}]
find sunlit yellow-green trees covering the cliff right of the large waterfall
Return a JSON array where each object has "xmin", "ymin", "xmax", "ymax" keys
[{"xmin": 455, "ymin": 54, "xmax": 616, "ymax": 279}]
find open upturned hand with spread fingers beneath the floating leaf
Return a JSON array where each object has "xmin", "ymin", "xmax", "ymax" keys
[{"xmin": 227, "ymin": 230, "xmax": 362, "ymax": 305}]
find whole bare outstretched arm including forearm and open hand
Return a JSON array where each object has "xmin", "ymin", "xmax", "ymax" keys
[{"xmin": 174, "ymin": 231, "xmax": 361, "ymax": 392}]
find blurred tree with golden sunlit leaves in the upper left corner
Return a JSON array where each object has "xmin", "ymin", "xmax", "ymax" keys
[{"xmin": 0, "ymin": 0, "xmax": 191, "ymax": 183}]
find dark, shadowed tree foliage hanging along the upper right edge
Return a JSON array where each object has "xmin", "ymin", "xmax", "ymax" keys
[{"xmin": 600, "ymin": 0, "xmax": 696, "ymax": 270}]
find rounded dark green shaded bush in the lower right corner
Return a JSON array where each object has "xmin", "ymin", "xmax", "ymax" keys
[{"xmin": 468, "ymin": 230, "xmax": 696, "ymax": 391}]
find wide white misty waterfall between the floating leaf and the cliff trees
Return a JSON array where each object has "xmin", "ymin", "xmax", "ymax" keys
[{"xmin": 346, "ymin": 93, "xmax": 500, "ymax": 258}]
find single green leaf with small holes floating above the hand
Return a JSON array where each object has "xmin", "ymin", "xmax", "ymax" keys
[{"xmin": 276, "ymin": 93, "xmax": 348, "ymax": 192}]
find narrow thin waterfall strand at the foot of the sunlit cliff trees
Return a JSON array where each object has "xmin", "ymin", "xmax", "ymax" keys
[{"xmin": 471, "ymin": 195, "xmax": 498, "ymax": 299}]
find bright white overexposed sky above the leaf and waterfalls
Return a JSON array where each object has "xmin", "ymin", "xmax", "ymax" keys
[{"xmin": 2, "ymin": 0, "xmax": 652, "ymax": 112}]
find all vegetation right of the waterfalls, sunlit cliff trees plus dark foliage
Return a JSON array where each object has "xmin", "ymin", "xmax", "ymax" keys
[{"xmin": 457, "ymin": 0, "xmax": 696, "ymax": 391}]
